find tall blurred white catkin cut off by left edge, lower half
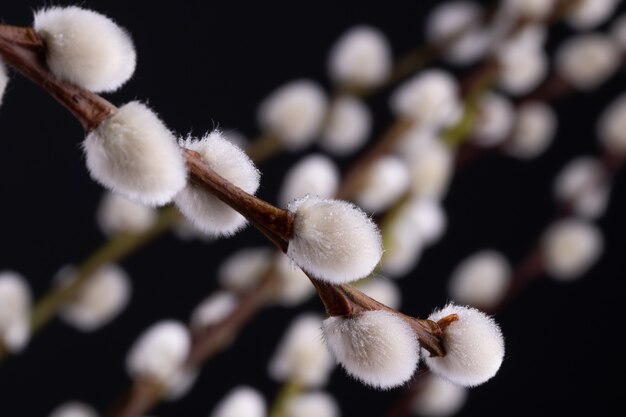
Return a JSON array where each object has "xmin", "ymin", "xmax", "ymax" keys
[{"xmin": 0, "ymin": 270, "xmax": 32, "ymax": 353}]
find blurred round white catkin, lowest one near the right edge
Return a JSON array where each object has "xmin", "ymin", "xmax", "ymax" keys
[{"xmin": 541, "ymin": 218, "xmax": 604, "ymax": 281}]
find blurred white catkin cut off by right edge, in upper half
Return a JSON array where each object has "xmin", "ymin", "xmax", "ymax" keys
[{"xmin": 597, "ymin": 94, "xmax": 626, "ymax": 156}]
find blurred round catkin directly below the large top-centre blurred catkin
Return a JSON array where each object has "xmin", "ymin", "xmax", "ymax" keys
[{"xmin": 319, "ymin": 95, "xmax": 372, "ymax": 156}]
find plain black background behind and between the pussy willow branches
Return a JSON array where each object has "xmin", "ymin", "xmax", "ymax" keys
[{"xmin": 0, "ymin": 1, "xmax": 626, "ymax": 417}]
